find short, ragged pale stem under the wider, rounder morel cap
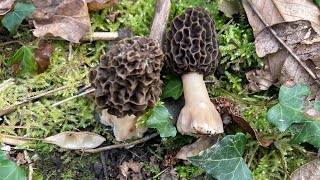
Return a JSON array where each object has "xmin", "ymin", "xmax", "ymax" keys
[{"xmin": 100, "ymin": 109, "xmax": 147, "ymax": 141}]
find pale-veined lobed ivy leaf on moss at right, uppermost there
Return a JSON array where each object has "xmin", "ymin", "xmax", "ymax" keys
[{"xmin": 268, "ymin": 84, "xmax": 311, "ymax": 131}]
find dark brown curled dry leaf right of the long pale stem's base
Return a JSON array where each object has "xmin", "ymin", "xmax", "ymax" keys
[{"xmin": 211, "ymin": 97, "xmax": 272, "ymax": 147}]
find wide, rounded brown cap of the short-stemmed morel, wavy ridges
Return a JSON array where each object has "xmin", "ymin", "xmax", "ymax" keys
[{"xmin": 89, "ymin": 37, "xmax": 163, "ymax": 118}]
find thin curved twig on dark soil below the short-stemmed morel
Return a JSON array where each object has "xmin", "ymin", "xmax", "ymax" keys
[{"xmin": 83, "ymin": 133, "xmax": 159, "ymax": 153}]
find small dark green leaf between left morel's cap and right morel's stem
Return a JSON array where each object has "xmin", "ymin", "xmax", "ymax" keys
[{"xmin": 161, "ymin": 76, "xmax": 183, "ymax": 100}]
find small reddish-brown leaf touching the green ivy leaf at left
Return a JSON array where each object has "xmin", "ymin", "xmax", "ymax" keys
[{"xmin": 35, "ymin": 40, "xmax": 54, "ymax": 74}]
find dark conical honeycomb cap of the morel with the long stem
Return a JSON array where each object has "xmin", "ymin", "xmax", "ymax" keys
[{"xmin": 166, "ymin": 7, "xmax": 220, "ymax": 76}]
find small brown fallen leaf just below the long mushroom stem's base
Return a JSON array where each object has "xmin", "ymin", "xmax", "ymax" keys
[{"xmin": 176, "ymin": 136, "xmax": 218, "ymax": 160}]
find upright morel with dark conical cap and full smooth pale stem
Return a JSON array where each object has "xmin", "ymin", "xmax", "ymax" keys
[{"xmin": 166, "ymin": 7, "xmax": 223, "ymax": 136}]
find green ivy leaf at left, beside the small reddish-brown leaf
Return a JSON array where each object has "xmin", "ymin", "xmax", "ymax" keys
[{"xmin": 8, "ymin": 46, "xmax": 37, "ymax": 74}]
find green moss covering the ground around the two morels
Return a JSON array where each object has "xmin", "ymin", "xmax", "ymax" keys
[{"xmin": 0, "ymin": 0, "xmax": 308, "ymax": 179}]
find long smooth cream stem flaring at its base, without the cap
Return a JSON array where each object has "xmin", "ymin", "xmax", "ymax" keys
[{"xmin": 177, "ymin": 72, "xmax": 223, "ymax": 136}]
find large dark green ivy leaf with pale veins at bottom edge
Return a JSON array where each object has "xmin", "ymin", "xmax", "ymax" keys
[{"xmin": 188, "ymin": 133, "xmax": 252, "ymax": 180}]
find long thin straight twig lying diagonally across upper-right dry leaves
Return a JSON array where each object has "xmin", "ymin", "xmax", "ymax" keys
[{"xmin": 247, "ymin": 0, "xmax": 320, "ymax": 84}]
